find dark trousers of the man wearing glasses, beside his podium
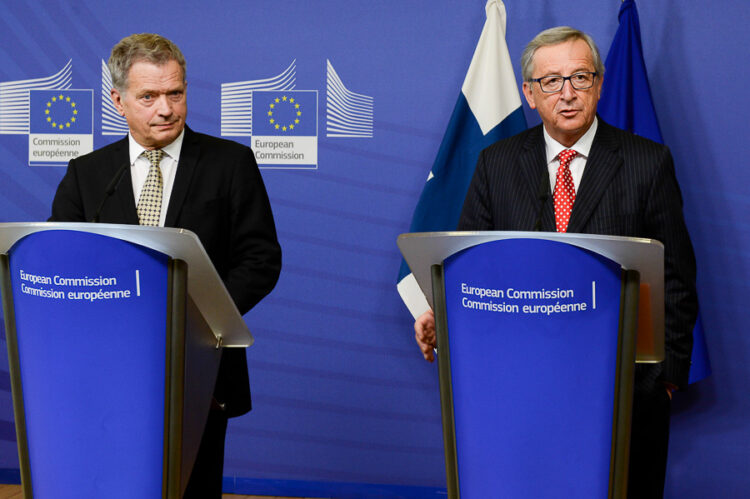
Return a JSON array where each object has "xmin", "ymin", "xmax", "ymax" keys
[{"xmin": 628, "ymin": 383, "xmax": 671, "ymax": 499}]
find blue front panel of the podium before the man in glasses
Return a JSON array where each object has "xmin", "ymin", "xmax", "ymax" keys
[{"xmin": 444, "ymin": 239, "xmax": 632, "ymax": 499}]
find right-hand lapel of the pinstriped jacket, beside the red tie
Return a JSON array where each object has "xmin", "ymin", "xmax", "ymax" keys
[{"xmin": 568, "ymin": 118, "xmax": 622, "ymax": 232}]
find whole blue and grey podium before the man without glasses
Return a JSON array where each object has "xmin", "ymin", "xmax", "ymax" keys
[{"xmin": 0, "ymin": 223, "xmax": 253, "ymax": 499}]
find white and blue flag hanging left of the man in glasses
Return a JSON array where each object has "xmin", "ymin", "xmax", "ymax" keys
[{"xmin": 398, "ymin": 0, "xmax": 526, "ymax": 317}]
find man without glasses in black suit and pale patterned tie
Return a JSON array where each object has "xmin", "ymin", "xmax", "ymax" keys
[{"xmin": 50, "ymin": 34, "xmax": 281, "ymax": 499}]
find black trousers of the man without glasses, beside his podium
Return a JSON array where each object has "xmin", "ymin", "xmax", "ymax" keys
[{"xmin": 183, "ymin": 409, "xmax": 227, "ymax": 499}]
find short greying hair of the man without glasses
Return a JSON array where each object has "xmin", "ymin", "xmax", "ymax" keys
[{"xmin": 107, "ymin": 33, "xmax": 185, "ymax": 92}]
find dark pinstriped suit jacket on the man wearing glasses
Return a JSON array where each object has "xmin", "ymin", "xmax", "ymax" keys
[{"xmin": 458, "ymin": 118, "xmax": 698, "ymax": 390}]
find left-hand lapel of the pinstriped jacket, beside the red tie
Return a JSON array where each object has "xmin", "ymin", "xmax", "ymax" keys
[{"xmin": 518, "ymin": 125, "xmax": 555, "ymax": 231}]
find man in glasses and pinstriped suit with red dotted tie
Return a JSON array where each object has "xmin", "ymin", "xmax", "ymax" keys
[{"xmin": 415, "ymin": 27, "xmax": 698, "ymax": 498}]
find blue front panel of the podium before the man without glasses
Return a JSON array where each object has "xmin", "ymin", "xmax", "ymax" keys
[{"xmin": 8, "ymin": 230, "xmax": 168, "ymax": 499}]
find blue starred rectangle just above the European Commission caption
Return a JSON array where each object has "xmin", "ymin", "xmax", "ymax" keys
[{"xmin": 253, "ymin": 90, "xmax": 318, "ymax": 137}]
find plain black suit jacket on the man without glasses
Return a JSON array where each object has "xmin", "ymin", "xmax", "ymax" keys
[{"xmin": 50, "ymin": 127, "xmax": 281, "ymax": 416}]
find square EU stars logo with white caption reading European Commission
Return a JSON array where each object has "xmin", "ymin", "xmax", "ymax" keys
[{"xmin": 252, "ymin": 90, "xmax": 318, "ymax": 168}]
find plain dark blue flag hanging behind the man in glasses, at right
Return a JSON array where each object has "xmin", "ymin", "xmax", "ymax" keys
[{"xmin": 598, "ymin": 0, "xmax": 711, "ymax": 383}]
